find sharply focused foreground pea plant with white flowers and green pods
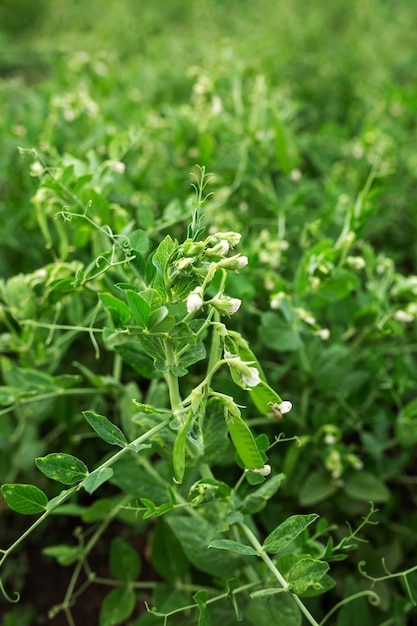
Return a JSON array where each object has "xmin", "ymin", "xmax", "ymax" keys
[{"xmin": 0, "ymin": 160, "xmax": 377, "ymax": 626}]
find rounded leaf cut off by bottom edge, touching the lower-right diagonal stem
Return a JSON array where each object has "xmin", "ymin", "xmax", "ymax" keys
[{"xmin": 245, "ymin": 593, "xmax": 303, "ymax": 626}]
